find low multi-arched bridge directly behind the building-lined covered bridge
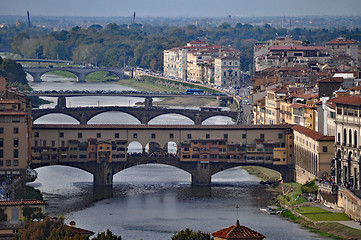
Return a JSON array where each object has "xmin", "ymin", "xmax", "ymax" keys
[{"xmin": 32, "ymin": 106, "xmax": 242, "ymax": 125}]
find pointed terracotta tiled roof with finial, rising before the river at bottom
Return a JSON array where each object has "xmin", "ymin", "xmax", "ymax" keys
[{"xmin": 212, "ymin": 220, "xmax": 265, "ymax": 239}]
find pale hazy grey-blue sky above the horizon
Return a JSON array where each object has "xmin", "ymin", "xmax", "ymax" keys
[{"xmin": 0, "ymin": 0, "xmax": 361, "ymax": 17}]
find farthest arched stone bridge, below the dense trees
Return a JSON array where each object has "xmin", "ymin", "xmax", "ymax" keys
[{"xmin": 24, "ymin": 67, "xmax": 125, "ymax": 82}]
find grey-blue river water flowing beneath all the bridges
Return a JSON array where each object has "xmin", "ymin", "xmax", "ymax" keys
[{"xmin": 29, "ymin": 75, "xmax": 323, "ymax": 240}]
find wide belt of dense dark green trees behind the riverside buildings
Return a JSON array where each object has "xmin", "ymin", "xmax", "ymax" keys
[{"xmin": 0, "ymin": 23, "xmax": 361, "ymax": 71}]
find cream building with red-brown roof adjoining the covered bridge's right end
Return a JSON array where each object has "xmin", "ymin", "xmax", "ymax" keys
[{"xmin": 292, "ymin": 125, "xmax": 335, "ymax": 184}]
